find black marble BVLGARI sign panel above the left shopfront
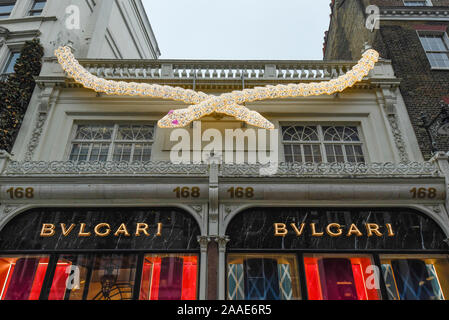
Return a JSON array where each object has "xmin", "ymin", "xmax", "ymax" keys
[{"xmin": 0, "ymin": 208, "xmax": 201, "ymax": 251}]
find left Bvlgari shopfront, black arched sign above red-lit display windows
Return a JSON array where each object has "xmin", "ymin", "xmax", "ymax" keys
[{"xmin": 0, "ymin": 208, "xmax": 200, "ymax": 300}]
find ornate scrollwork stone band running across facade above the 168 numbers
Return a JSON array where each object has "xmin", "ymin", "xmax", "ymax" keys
[{"xmin": 3, "ymin": 161, "xmax": 443, "ymax": 178}]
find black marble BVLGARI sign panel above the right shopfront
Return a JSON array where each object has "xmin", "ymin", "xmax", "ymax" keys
[{"xmin": 226, "ymin": 208, "xmax": 449, "ymax": 250}]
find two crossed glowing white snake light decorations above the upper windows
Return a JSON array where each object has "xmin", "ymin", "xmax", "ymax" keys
[{"xmin": 55, "ymin": 47, "xmax": 379, "ymax": 129}]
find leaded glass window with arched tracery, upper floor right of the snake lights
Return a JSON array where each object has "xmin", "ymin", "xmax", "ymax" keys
[{"xmin": 282, "ymin": 125, "xmax": 365, "ymax": 163}]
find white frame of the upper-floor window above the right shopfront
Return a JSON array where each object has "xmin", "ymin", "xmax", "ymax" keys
[{"xmin": 279, "ymin": 122, "xmax": 369, "ymax": 164}]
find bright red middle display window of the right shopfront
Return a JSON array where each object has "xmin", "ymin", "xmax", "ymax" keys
[{"xmin": 304, "ymin": 254, "xmax": 381, "ymax": 300}]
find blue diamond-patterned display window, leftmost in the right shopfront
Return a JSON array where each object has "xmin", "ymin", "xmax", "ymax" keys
[{"xmin": 227, "ymin": 254, "xmax": 301, "ymax": 300}]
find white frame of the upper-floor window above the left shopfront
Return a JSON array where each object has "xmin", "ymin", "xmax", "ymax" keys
[{"xmin": 64, "ymin": 120, "xmax": 156, "ymax": 163}]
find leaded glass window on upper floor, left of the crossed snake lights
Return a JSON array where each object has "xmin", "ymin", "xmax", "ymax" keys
[{"xmin": 69, "ymin": 124, "xmax": 154, "ymax": 162}]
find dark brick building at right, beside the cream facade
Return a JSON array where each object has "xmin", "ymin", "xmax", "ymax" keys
[{"xmin": 324, "ymin": 0, "xmax": 449, "ymax": 159}]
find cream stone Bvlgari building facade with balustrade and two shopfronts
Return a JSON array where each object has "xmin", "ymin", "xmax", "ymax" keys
[{"xmin": 0, "ymin": 0, "xmax": 449, "ymax": 300}]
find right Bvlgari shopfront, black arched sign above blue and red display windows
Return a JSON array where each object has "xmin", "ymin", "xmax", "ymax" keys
[{"xmin": 226, "ymin": 208, "xmax": 449, "ymax": 300}]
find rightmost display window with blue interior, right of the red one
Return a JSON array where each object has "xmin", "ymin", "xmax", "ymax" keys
[{"xmin": 380, "ymin": 255, "xmax": 449, "ymax": 300}]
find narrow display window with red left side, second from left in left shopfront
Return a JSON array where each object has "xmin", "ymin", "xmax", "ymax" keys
[{"xmin": 48, "ymin": 255, "xmax": 91, "ymax": 300}]
